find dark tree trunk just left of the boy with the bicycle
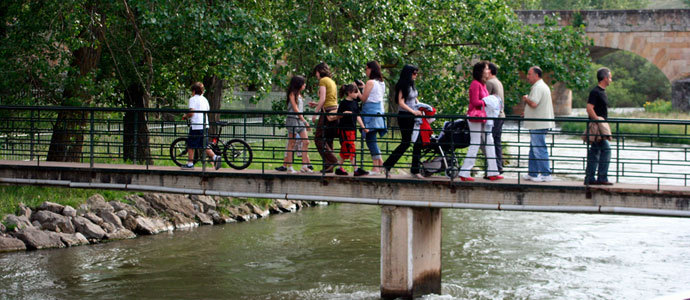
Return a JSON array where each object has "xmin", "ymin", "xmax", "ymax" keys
[{"xmin": 122, "ymin": 83, "xmax": 153, "ymax": 164}]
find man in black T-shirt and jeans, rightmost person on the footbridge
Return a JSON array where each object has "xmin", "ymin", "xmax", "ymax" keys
[{"xmin": 585, "ymin": 68, "xmax": 613, "ymax": 185}]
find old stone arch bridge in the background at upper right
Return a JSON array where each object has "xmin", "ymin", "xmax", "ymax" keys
[{"xmin": 516, "ymin": 9, "xmax": 690, "ymax": 111}]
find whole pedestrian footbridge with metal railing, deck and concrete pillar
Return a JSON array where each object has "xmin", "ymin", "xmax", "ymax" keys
[{"xmin": 0, "ymin": 107, "xmax": 690, "ymax": 298}]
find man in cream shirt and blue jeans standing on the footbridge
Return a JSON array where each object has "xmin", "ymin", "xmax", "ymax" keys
[{"xmin": 522, "ymin": 66, "xmax": 556, "ymax": 181}]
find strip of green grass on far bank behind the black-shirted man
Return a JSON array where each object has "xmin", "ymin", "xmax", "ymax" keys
[{"xmin": 560, "ymin": 112, "xmax": 690, "ymax": 144}]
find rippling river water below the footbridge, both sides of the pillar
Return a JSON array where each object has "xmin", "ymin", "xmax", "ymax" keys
[{"xmin": 0, "ymin": 204, "xmax": 690, "ymax": 299}]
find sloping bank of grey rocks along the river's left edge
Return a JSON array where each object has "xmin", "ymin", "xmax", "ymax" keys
[{"xmin": 0, "ymin": 188, "xmax": 324, "ymax": 252}]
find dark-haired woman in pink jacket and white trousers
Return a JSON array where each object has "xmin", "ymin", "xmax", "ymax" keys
[{"xmin": 460, "ymin": 61, "xmax": 503, "ymax": 181}]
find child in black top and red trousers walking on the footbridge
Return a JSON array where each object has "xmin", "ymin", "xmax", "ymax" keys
[{"xmin": 328, "ymin": 84, "xmax": 369, "ymax": 176}]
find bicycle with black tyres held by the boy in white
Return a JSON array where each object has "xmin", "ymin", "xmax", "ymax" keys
[{"xmin": 170, "ymin": 121, "xmax": 253, "ymax": 170}]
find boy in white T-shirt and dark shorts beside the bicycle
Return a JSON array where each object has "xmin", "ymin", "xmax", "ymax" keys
[{"xmin": 182, "ymin": 82, "xmax": 221, "ymax": 170}]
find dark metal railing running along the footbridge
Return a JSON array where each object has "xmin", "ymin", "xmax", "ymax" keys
[{"xmin": 0, "ymin": 106, "xmax": 690, "ymax": 188}]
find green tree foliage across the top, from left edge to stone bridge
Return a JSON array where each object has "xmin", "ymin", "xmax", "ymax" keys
[{"xmin": 0, "ymin": 0, "xmax": 584, "ymax": 113}]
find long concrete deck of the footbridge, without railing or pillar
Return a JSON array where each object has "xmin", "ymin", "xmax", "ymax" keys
[{"xmin": 0, "ymin": 161, "xmax": 690, "ymax": 216}]
